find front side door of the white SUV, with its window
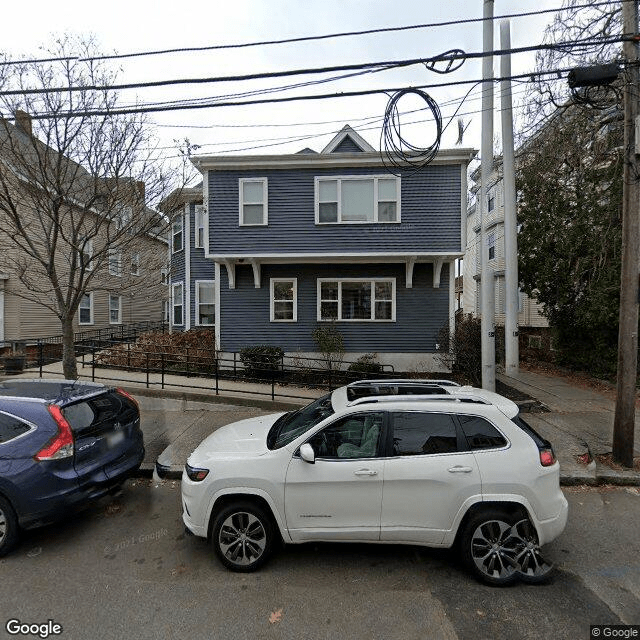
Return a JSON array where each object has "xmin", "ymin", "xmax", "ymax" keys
[{"xmin": 285, "ymin": 412, "xmax": 384, "ymax": 542}]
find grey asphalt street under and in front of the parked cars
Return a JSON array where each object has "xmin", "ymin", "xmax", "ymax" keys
[{"xmin": 0, "ymin": 479, "xmax": 640, "ymax": 640}]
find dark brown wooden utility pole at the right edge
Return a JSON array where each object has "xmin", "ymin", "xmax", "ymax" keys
[{"xmin": 613, "ymin": 0, "xmax": 640, "ymax": 467}]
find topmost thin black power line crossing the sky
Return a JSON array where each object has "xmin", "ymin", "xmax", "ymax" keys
[{"xmin": 0, "ymin": 0, "xmax": 620, "ymax": 66}]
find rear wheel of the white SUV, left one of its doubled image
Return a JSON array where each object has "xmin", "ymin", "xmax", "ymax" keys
[{"xmin": 461, "ymin": 509, "xmax": 520, "ymax": 586}]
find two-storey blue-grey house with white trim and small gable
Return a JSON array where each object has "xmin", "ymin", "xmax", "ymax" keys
[{"xmin": 169, "ymin": 126, "xmax": 474, "ymax": 371}]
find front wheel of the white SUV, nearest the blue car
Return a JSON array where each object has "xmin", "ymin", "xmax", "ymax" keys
[{"xmin": 211, "ymin": 502, "xmax": 275, "ymax": 573}]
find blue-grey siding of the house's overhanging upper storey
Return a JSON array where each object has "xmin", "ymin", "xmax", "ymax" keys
[{"xmin": 207, "ymin": 164, "xmax": 461, "ymax": 255}]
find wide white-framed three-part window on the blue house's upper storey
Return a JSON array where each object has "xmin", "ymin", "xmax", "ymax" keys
[{"xmin": 315, "ymin": 176, "xmax": 400, "ymax": 224}]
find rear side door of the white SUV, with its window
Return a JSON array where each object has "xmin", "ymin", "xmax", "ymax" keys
[{"xmin": 380, "ymin": 411, "xmax": 482, "ymax": 544}]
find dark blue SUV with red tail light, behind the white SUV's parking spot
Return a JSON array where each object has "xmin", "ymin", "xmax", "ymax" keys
[{"xmin": 0, "ymin": 379, "xmax": 144, "ymax": 556}]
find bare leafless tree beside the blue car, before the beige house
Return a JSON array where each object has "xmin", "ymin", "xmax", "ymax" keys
[{"xmin": 0, "ymin": 38, "xmax": 190, "ymax": 379}]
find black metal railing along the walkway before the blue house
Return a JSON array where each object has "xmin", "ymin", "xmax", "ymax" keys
[{"xmin": 31, "ymin": 339, "xmax": 397, "ymax": 401}]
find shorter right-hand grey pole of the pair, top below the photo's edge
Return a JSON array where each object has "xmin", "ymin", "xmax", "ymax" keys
[{"xmin": 500, "ymin": 20, "xmax": 520, "ymax": 376}]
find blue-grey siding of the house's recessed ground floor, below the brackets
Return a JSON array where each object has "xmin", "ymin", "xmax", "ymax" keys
[{"xmin": 220, "ymin": 264, "xmax": 449, "ymax": 353}]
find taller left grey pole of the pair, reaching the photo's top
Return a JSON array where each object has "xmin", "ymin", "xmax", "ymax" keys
[{"xmin": 478, "ymin": 0, "xmax": 496, "ymax": 391}]
